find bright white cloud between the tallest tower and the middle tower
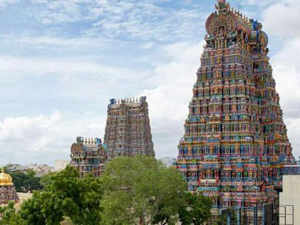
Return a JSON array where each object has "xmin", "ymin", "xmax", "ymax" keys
[{"xmin": 143, "ymin": 42, "xmax": 203, "ymax": 158}]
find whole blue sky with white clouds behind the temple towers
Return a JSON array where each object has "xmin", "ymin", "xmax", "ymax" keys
[{"xmin": 0, "ymin": 0, "xmax": 300, "ymax": 165}]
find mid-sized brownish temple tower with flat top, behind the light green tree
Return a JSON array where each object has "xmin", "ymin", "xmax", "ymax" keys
[{"xmin": 104, "ymin": 97, "xmax": 155, "ymax": 159}]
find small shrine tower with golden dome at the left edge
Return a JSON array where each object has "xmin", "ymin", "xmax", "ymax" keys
[{"xmin": 0, "ymin": 170, "xmax": 19, "ymax": 205}]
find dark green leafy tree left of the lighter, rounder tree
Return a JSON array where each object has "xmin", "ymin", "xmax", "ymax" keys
[{"xmin": 20, "ymin": 167, "xmax": 102, "ymax": 225}]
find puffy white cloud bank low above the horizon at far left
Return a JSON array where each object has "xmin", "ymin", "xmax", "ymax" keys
[{"xmin": 0, "ymin": 111, "xmax": 103, "ymax": 165}]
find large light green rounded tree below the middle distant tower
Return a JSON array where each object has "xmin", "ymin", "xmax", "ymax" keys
[{"xmin": 102, "ymin": 156, "xmax": 206, "ymax": 225}]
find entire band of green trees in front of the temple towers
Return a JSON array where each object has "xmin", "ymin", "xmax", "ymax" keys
[{"xmin": 0, "ymin": 156, "xmax": 212, "ymax": 225}]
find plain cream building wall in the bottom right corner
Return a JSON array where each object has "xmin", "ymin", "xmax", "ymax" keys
[{"xmin": 280, "ymin": 175, "xmax": 300, "ymax": 225}]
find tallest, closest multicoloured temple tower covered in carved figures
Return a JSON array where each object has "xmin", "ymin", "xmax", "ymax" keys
[{"xmin": 175, "ymin": 0, "xmax": 295, "ymax": 207}]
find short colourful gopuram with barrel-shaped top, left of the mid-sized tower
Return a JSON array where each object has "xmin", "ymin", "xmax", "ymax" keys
[{"xmin": 70, "ymin": 137, "xmax": 107, "ymax": 178}]
